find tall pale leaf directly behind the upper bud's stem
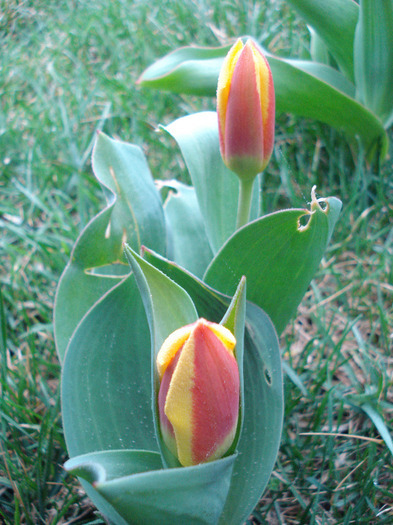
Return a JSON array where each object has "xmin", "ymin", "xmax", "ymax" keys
[{"xmin": 163, "ymin": 111, "xmax": 259, "ymax": 253}]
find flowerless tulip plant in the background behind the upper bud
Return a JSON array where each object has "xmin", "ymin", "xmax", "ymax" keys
[{"xmin": 139, "ymin": 0, "xmax": 393, "ymax": 163}]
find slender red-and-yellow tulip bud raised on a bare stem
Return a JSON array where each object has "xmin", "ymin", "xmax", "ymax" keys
[{"xmin": 217, "ymin": 40, "xmax": 275, "ymax": 180}]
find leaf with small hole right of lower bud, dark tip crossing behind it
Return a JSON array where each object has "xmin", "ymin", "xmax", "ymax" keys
[{"xmin": 138, "ymin": 251, "xmax": 283, "ymax": 525}]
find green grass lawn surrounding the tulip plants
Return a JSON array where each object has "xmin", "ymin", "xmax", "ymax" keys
[{"xmin": 0, "ymin": 0, "xmax": 393, "ymax": 525}]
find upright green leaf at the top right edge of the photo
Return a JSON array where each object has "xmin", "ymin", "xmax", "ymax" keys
[{"xmin": 355, "ymin": 0, "xmax": 393, "ymax": 128}]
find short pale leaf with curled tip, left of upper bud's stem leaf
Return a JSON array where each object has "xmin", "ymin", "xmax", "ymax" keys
[{"xmin": 163, "ymin": 180, "xmax": 213, "ymax": 277}]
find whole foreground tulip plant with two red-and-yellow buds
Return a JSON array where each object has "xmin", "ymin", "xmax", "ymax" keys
[{"xmin": 55, "ymin": 41, "xmax": 341, "ymax": 525}]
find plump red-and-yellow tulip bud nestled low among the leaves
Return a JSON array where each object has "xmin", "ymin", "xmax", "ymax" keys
[{"xmin": 157, "ymin": 319, "xmax": 240, "ymax": 466}]
